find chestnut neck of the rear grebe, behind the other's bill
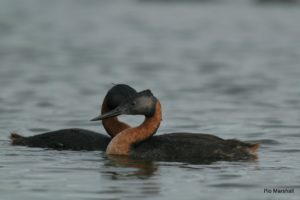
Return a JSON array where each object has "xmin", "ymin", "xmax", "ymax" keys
[{"xmin": 101, "ymin": 99, "xmax": 130, "ymax": 138}]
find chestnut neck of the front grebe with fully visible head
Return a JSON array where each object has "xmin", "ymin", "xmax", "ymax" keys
[{"xmin": 106, "ymin": 101, "xmax": 161, "ymax": 156}]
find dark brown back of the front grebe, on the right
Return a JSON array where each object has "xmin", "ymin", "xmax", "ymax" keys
[{"xmin": 130, "ymin": 133, "xmax": 257, "ymax": 163}]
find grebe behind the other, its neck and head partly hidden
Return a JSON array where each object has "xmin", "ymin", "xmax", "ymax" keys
[{"xmin": 10, "ymin": 84, "xmax": 136, "ymax": 151}]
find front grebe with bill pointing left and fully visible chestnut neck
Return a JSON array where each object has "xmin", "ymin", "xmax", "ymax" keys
[{"xmin": 93, "ymin": 90, "xmax": 259, "ymax": 163}]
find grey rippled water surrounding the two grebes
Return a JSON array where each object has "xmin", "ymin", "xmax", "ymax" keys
[{"xmin": 0, "ymin": 0, "xmax": 300, "ymax": 200}]
